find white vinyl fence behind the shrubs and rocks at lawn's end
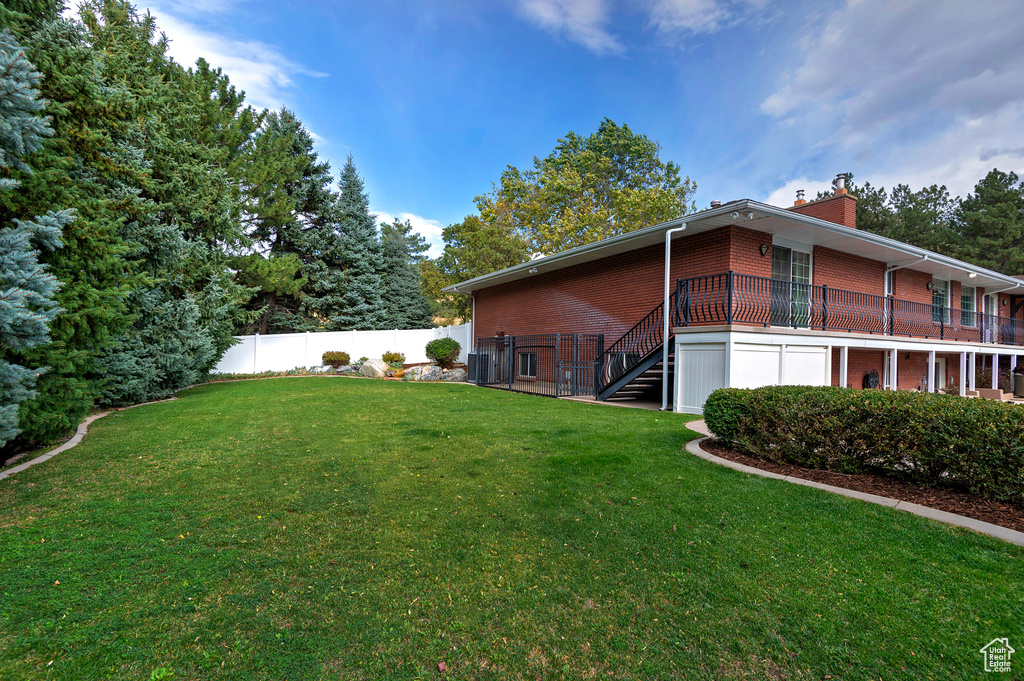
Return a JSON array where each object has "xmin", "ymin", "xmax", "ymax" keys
[{"xmin": 213, "ymin": 324, "xmax": 470, "ymax": 374}]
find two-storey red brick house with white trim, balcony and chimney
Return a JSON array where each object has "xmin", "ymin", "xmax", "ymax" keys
[{"xmin": 446, "ymin": 176, "xmax": 1024, "ymax": 413}]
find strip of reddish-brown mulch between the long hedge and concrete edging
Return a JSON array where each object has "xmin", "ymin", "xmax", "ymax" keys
[{"xmin": 700, "ymin": 439, "xmax": 1024, "ymax": 531}]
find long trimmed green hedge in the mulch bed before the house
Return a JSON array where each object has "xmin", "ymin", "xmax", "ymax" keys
[{"xmin": 705, "ymin": 386, "xmax": 1024, "ymax": 507}]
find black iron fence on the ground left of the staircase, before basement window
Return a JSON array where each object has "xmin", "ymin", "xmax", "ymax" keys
[{"xmin": 476, "ymin": 334, "xmax": 604, "ymax": 397}]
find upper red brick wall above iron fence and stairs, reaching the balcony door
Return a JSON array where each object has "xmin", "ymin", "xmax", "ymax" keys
[{"xmin": 475, "ymin": 226, "xmax": 771, "ymax": 342}]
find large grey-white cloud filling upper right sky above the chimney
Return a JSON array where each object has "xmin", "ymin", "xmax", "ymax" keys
[{"xmin": 761, "ymin": 0, "xmax": 1024, "ymax": 202}]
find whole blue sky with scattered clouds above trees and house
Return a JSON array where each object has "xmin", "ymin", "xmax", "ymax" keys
[{"xmin": 97, "ymin": 0, "xmax": 1024, "ymax": 254}]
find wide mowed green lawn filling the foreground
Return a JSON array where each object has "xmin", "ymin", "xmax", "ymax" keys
[{"xmin": 0, "ymin": 378, "xmax": 1024, "ymax": 680}]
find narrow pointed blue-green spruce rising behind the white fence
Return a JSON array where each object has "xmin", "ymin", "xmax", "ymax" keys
[{"xmin": 332, "ymin": 155, "xmax": 387, "ymax": 331}]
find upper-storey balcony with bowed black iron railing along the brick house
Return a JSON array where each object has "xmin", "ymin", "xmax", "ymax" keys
[{"xmin": 672, "ymin": 271, "xmax": 1024, "ymax": 346}]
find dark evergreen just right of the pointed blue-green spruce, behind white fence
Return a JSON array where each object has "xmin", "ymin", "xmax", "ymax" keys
[{"xmin": 381, "ymin": 219, "xmax": 433, "ymax": 329}]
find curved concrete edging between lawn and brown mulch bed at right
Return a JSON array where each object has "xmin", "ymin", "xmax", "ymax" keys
[{"xmin": 686, "ymin": 421, "xmax": 1024, "ymax": 546}]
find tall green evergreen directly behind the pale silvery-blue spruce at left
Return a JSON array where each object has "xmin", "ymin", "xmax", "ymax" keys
[{"xmin": 0, "ymin": 15, "xmax": 138, "ymax": 446}]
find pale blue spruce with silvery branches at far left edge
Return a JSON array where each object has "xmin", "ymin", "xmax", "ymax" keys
[{"xmin": 0, "ymin": 30, "xmax": 73, "ymax": 446}]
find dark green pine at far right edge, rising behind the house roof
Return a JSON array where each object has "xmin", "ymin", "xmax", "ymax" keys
[{"xmin": 959, "ymin": 169, "xmax": 1024, "ymax": 275}]
